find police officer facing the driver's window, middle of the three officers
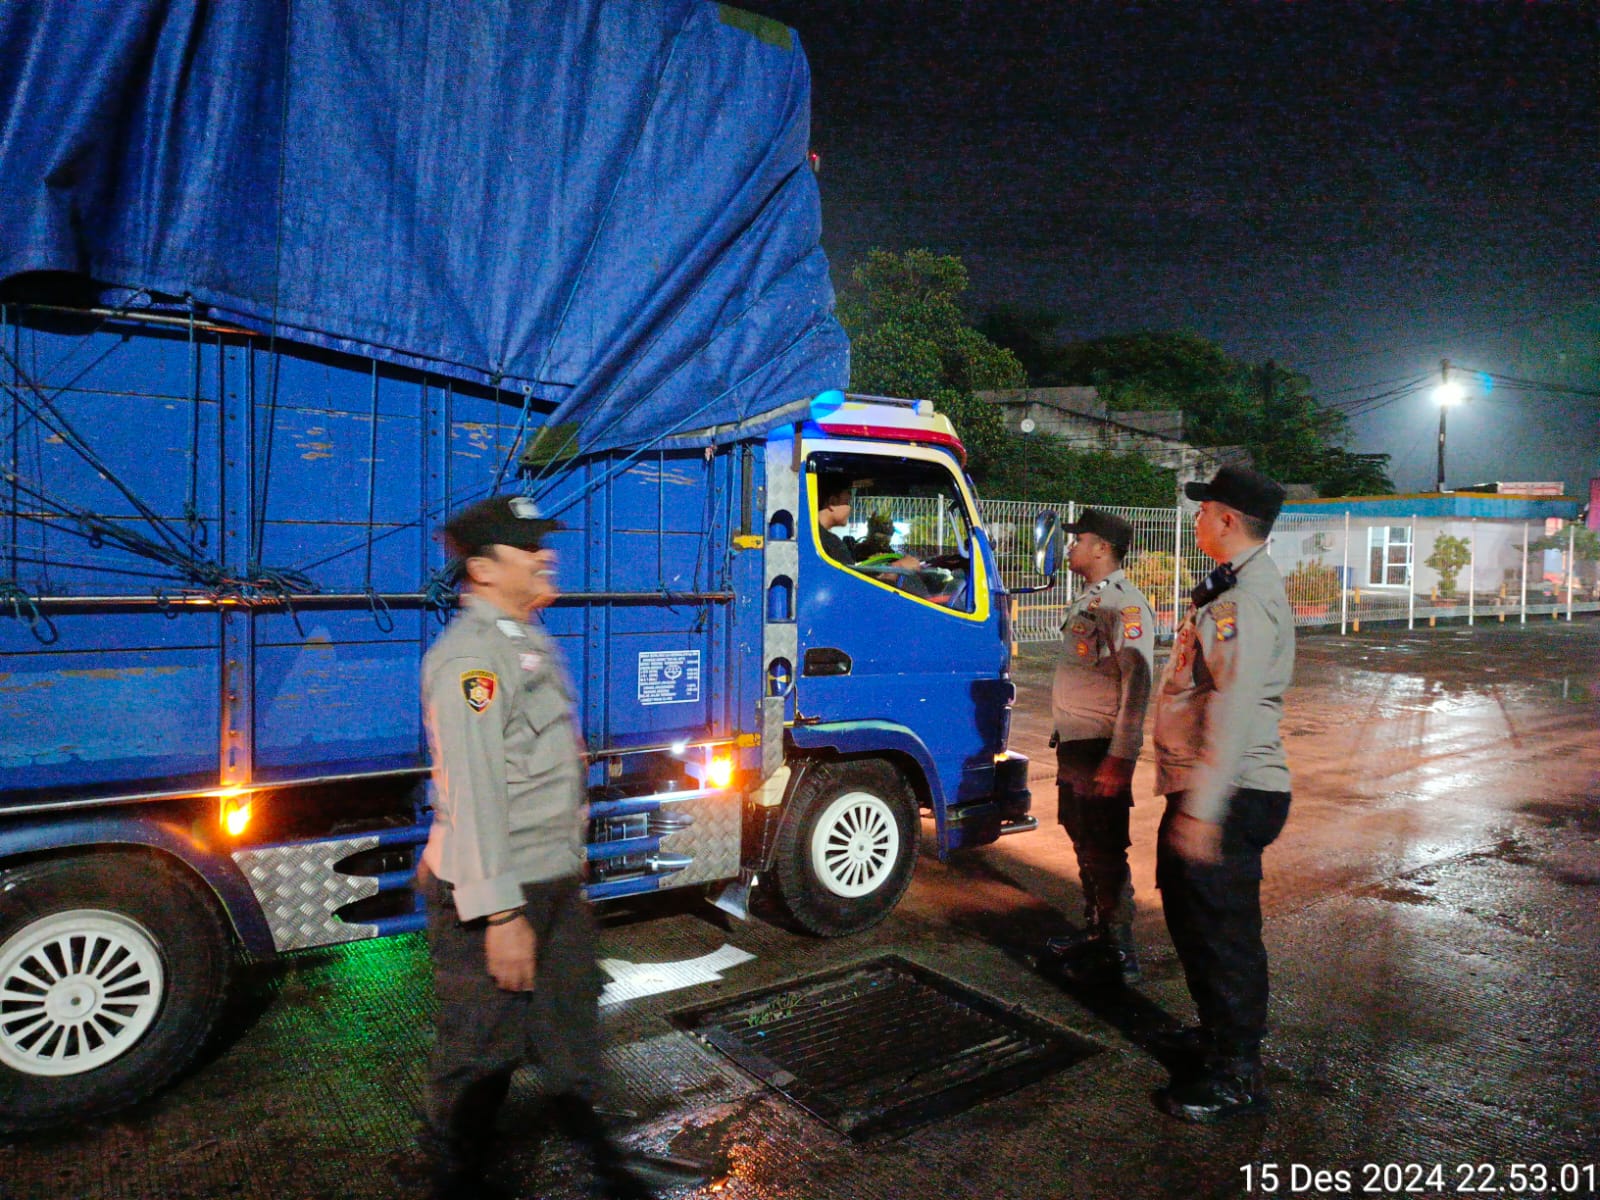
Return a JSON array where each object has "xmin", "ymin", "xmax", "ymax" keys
[{"xmin": 1045, "ymin": 509, "xmax": 1155, "ymax": 984}]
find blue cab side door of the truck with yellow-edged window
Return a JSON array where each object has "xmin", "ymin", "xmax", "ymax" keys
[{"xmin": 795, "ymin": 446, "xmax": 1011, "ymax": 854}]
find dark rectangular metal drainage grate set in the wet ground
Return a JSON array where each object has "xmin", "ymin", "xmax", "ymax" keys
[{"xmin": 674, "ymin": 955, "xmax": 1101, "ymax": 1141}]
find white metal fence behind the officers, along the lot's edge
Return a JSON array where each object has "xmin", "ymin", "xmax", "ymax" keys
[{"xmin": 979, "ymin": 499, "xmax": 1600, "ymax": 642}]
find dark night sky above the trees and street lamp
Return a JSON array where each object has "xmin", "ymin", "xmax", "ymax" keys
[{"xmin": 749, "ymin": 0, "xmax": 1600, "ymax": 494}]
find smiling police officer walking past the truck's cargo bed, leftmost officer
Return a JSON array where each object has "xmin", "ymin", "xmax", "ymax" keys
[{"xmin": 418, "ymin": 496, "xmax": 704, "ymax": 1197}]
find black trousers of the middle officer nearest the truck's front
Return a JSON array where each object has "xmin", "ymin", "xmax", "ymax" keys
[{"xmin": 1056, "ymin": 738, "xmax": 1133, "ymax": 928}]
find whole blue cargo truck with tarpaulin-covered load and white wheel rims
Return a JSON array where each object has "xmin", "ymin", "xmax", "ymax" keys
[{"xmin": 0, "ymin": 0, "xmax": 1056, "ymax": 1130}]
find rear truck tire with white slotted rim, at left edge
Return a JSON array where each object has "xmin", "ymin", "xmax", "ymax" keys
[{"xmin": 0, "ymin": 853, "xmax": 230, "ymax": 1131}]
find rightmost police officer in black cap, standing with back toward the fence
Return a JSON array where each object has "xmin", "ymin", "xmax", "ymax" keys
[{"xmin": 1155, "ymin": 467, "xmax": 1294, "ymax": 1122}]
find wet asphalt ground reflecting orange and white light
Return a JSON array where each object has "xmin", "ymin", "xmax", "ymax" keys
[{"xmin": 0, "ymin": 619, "xmax": 1600, "ymax": 1200}]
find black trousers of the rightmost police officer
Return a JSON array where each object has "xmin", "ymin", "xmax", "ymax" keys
[{"xmin": 1155, "ymin": 787, "xmax": 1290, "ymax": 1061}]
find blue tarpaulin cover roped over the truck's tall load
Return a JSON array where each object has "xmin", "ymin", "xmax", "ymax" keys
[{"xmin": 0, "ymin": 0, "xmax": 848, "ymax": 451}]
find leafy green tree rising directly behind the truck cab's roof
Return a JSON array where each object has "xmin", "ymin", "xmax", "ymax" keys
[{"xmin": 838, "ymin": 250, "xmax": 1027, "ymax": 478}]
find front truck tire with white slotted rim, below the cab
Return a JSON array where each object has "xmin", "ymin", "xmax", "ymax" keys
[{"xmin": 773, "ymin": 758, "xmax": 918, "ymax": 938}]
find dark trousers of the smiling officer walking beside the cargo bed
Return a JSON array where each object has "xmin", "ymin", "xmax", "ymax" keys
[{"xmin": 422, "ymin": 878, "xmax": 602, "ymax": 1168}]
